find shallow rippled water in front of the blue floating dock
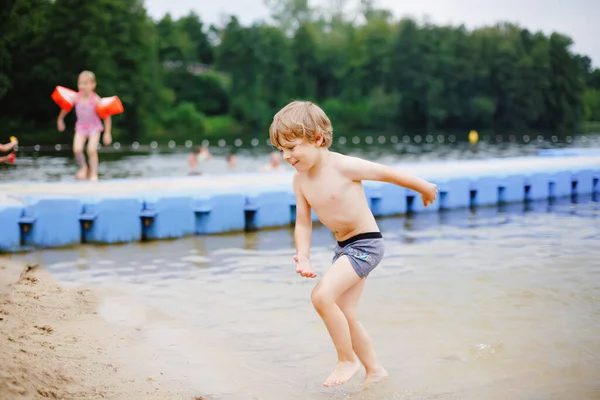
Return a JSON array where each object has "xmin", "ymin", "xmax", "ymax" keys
[{"xmin": 5, "ymin": 199, "xmax": 600, "ymax": 400}]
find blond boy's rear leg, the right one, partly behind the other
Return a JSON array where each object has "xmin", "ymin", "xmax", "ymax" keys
[{"xmin": 336, "ymin": 279, "xmax": 387, "ymax": 384}]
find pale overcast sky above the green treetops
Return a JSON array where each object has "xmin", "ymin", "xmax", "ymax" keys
[{"xmin": 145, "ymin": 0, "xmax": 600, "ymax": 67}]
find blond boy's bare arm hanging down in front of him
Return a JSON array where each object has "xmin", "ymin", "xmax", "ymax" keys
[{"xmin": 294, "ymin": 174, "xmax": 317, "ymax": 278}]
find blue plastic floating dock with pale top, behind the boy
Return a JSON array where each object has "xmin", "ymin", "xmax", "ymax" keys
[{"xmin": 0, "ymin": 150, "xmax": 600, "ymax": 252}]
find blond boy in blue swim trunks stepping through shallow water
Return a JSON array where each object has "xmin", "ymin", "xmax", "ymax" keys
[{"xmin": 269, "ymin": 101, "xmax": 438, "ymax": 386}]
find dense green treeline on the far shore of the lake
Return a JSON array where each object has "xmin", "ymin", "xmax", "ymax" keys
[{"xmin": 0, "ymin": 0, "xmax": 600, "ymax": 142}]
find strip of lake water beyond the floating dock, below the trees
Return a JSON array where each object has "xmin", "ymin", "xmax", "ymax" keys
[{"xmin": 0, "ymin": 134, "xmax": 600, "ymax": 182}]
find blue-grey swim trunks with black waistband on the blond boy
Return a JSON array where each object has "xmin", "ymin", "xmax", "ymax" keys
[{"xmin": 332, "ymin": 232, "xmax": 384, "ymax": 278}]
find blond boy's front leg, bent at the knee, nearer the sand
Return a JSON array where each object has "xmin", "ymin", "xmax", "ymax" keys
[{"xmin": 311, "ymin": 255, "xmax": 361, "ymax": 386}]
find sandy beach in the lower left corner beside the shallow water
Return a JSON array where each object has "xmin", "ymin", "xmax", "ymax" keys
[{"xmin": 0, "ymin": 257, "xmax": 203, "ymax": 400}]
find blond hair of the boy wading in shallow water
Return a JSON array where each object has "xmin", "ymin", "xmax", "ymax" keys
[{"xmin": 269, "ymin": 100, "xmax": 333, "ymax": 148}]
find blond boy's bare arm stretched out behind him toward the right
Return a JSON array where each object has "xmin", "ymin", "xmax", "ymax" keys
[{"xmin": 341, "ymin": 156, "xmax": 438, "ymax": 206}]
